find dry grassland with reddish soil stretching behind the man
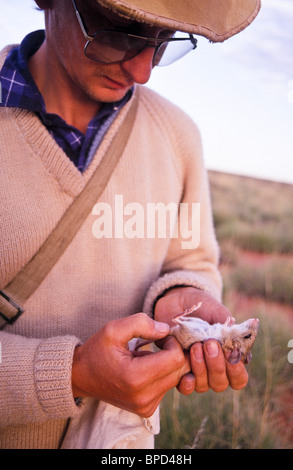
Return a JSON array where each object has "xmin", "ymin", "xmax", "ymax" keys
[{"xmin": 156, "ymin": 172, "xmax": 293, "ymax": 449}]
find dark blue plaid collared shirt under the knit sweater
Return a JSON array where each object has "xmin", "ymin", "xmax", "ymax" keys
[{"xmin": 0, "ymin": 31, "xmax": 132, "ymax": 171}]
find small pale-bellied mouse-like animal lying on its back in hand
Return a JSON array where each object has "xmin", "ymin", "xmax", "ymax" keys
[{"xmin": 170, "ymin": 302, "xmax": 259, "ymax": 364}]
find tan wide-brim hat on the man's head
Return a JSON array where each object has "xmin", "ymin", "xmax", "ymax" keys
[{"xmin": 97, "ymin": 0, "xmax": 261, "ymax": 42}]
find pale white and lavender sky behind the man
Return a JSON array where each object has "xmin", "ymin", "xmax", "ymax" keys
[{"xmin": 0, "ymin": 0, "xmax": 293, "ymax": 183}]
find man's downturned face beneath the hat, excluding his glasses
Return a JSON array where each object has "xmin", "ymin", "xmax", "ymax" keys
[{"xmin": 46, "ymin": 0, "xmax": 165, "ymax": 102}]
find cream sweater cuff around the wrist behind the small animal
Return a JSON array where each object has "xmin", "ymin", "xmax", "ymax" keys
[{"xmin": 143, "ymin": 271, "xmax": 222, "ymax": 318}]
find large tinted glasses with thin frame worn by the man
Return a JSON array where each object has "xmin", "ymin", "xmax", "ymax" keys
[{"xmin": 72, "ymin": 0, "xmax": 197, "ymax": 67}]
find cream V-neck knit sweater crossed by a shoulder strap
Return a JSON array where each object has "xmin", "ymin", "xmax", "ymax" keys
[{"xmin": 0, "ymin": 47, "xmax": 221, "ymax": 448}]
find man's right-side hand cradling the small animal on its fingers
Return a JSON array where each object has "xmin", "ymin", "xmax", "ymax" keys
[{"xmin": 155, "ymin": 287, "xmax": 248, "ymax": 395}]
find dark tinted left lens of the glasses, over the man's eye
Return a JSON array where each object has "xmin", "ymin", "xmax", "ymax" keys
[{"xmin": 85, "ymin": 31, "xmax": 147, "ymax": 64}]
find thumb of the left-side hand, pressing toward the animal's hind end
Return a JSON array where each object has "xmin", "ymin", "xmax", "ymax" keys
[{"xmin": 108, "ymin": 313, "xmax": 170, "ymax": 345}]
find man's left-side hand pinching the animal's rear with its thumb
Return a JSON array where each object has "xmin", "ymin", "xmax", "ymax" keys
[{"xmin": 72, "ymin": 313, "xmax": 191, "ymax": 417}]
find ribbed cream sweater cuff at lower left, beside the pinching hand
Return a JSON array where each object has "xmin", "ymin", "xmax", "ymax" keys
[{"xmin": 34, "ymin": 336, "xmax": 80, "ymax": 419}]
